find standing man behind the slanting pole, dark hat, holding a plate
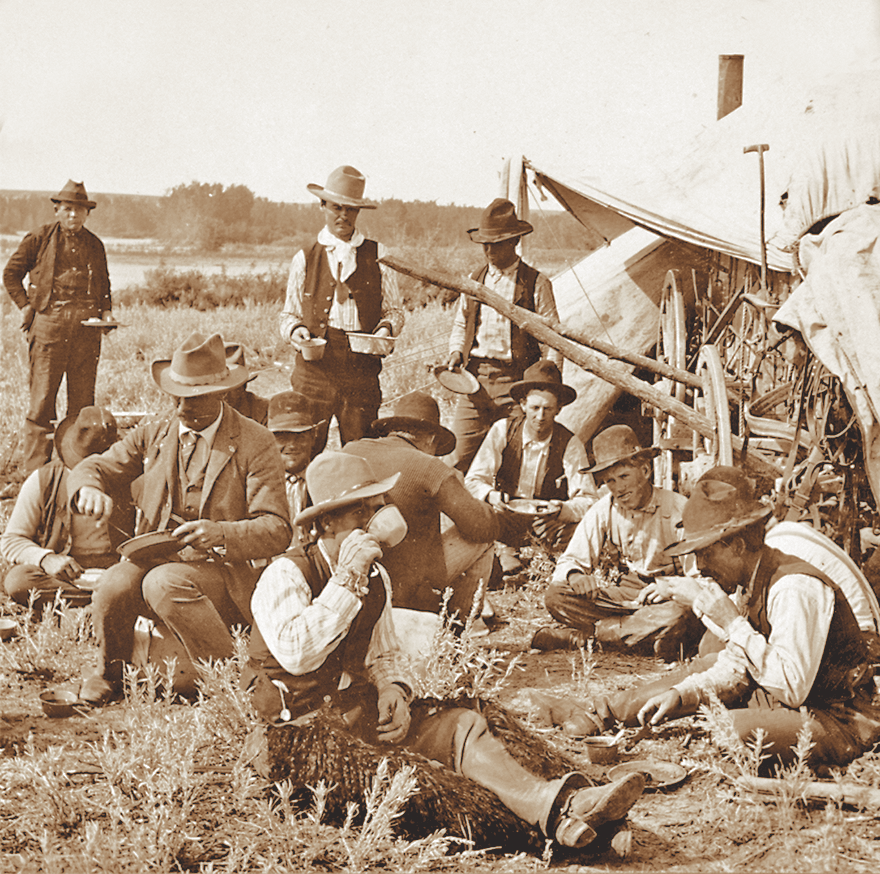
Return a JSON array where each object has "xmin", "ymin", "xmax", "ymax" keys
[{"xmin": 447, "ymin": 198, "xmax": 562, "ymax": 473}]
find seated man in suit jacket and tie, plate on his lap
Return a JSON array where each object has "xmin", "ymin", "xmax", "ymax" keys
[{"xmin": 68, "ymin": 333, "xmax": 291, "ymax": 704}]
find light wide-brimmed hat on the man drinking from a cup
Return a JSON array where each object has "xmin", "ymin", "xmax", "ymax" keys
[{"xmin": 293, "ymin": 452, "xmax": 400, "ymax": 525}]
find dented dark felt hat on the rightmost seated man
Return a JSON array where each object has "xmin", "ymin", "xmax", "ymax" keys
[{"xmin": 664, "ymin": 466, "xmax": 772, "ymax": 556}]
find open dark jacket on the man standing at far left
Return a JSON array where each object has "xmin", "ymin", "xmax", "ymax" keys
[{"xmin": 3, "ymin": 222, "xmax": 112, "ymax": 313}]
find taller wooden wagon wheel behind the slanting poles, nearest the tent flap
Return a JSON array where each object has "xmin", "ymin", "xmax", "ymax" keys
[{"xmin": 654, "ymin": 270, "xmax": 687, "ymax": 489}]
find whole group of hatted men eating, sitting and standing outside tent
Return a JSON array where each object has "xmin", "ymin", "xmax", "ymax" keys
[{"xmin": 0, "ymin": 166, "xmax": 880, "ymax": 847}]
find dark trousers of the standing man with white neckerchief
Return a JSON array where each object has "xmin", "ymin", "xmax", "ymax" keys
[{"xmin": 290, "ymin": 328, "xmax": 382, "ymax": 455}]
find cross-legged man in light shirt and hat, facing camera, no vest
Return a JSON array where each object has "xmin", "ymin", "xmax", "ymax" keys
[{"xmin": 532, "ymin": 425, "xmax": 700, "ymax": 659}]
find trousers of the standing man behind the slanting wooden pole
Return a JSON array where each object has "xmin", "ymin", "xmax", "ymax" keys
[{"xmin": 450, "ymin": 358, "xmax": 523, "ymax": 473}]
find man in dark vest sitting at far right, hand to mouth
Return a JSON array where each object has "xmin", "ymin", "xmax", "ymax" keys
[{"xmin": 572, "ymin": 467, "xmax": 880, "ymax": 769}]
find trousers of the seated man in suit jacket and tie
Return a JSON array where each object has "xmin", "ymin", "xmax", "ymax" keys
[{"xmin": 92, "ymin": 561, "xmax": 248, "ymax": 683}]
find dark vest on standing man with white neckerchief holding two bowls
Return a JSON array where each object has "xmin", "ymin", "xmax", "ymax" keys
[{"xmin": 303, "ymin": 240, "xmax": 382, "ymax": 337}]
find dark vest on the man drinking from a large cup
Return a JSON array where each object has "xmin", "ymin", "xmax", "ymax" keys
[{"xmin": 243, "ymin": 543, "xmax": 386, "ymax": 719}]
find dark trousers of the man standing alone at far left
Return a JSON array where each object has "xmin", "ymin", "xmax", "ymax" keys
[{"xmin": 24, "ymin": 303, "xmax": 101, "ymax": 473}]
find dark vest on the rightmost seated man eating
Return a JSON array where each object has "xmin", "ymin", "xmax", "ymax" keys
[{"xmin": 748, "ymin": 547, "xmax": 870, "ymax": 709}]
